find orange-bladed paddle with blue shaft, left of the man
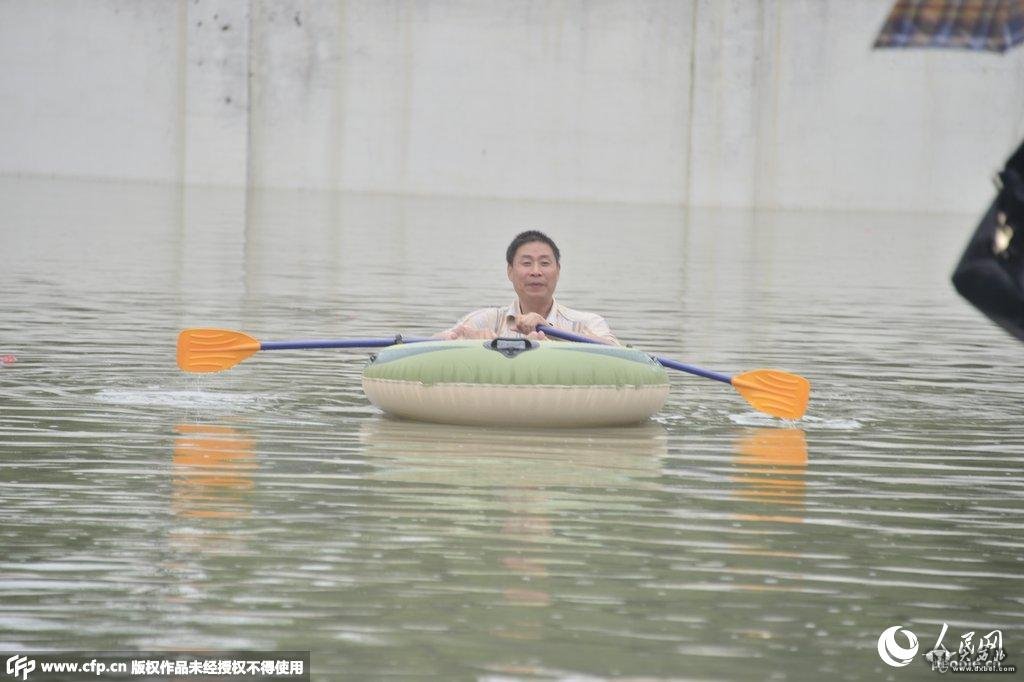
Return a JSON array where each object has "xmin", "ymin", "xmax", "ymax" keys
[{"xmin": 178, "ymin": 329, "xmax": 431, "ymax": 372}]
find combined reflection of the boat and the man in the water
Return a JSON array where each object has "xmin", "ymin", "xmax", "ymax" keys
[{"xmin": 361, "ymin": 418, "xmax": 668, "ymax": 640}]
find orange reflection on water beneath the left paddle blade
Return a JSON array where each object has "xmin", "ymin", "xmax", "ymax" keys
[{"xmin": 171, "ymin": 424, "xmax": 257, "ymax": 518}]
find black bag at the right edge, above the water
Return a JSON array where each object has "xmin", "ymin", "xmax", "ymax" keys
[{"xmin": 953, "ymin": 137, "xmax": 1024, "ymax": 341}]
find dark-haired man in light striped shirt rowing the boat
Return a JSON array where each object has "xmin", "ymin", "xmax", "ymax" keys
[{"xmin": 437, "ymin": 229, "xmax": 620, "ymax": 345}]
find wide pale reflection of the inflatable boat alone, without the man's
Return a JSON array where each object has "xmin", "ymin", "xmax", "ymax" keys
[{"xmin": 360, "ymin": 419, "xmax": 668, "ymax": 488}]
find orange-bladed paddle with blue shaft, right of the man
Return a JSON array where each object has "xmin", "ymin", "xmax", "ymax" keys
[{"xmin": 537, "ymin": 325, "xmax": 811, "ymax": 419}]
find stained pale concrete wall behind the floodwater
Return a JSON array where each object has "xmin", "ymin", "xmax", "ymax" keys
[{"xmin": 0, "ymin": 0, "xmax": 1024, "ymax": 212}]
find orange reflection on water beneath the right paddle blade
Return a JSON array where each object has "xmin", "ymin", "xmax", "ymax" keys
[{"xmin": 732, "ymin": 428, "xmax": 807, "ymax": 523}]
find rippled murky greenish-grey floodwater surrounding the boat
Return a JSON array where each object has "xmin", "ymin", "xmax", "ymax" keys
[{"xmin": 0, "ymin": 179, "xmax": 1024, "ymax": 681}]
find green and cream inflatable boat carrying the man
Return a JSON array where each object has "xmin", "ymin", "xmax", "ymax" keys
[{"xmin": 362, "ymin": 339, "xmax": 669, "ymax": 427}]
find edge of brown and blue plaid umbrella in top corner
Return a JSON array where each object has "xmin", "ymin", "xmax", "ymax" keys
[{"xmin": 874, "ymin": 0, "xmax": 1024, "ymax": 52}]
